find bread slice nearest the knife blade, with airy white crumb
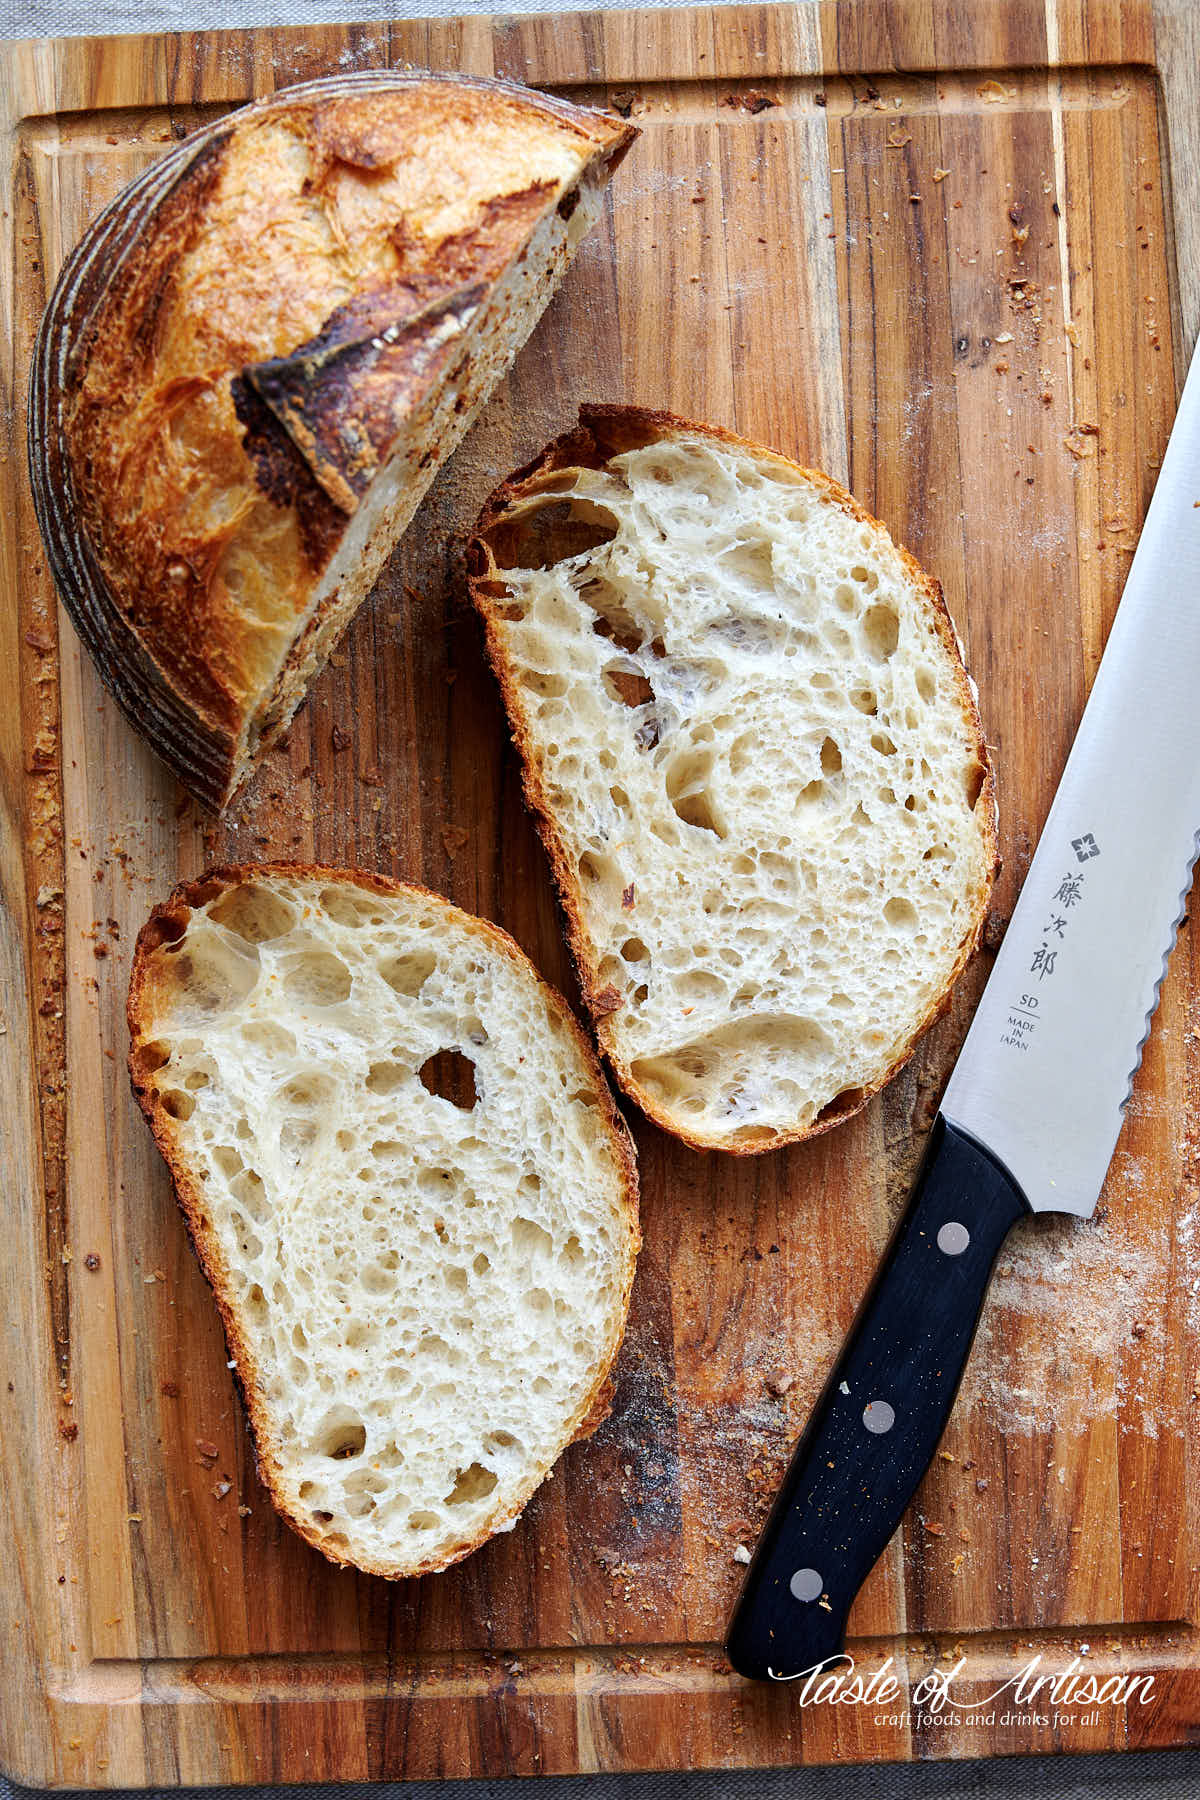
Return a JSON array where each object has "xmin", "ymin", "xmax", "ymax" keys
[{"xmin": 468, "ymin": 407, "xmax": 997, "ymax": 1152}]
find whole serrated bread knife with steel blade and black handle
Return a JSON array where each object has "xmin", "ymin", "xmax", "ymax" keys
[{"xmin": 727, "ymin": 340, "xmax": 1200, "ymax": 1679}]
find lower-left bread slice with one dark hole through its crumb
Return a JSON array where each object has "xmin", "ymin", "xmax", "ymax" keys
[{"xmin": 130, "ymin": 864, "xmax": 639, "ymax": 1577}]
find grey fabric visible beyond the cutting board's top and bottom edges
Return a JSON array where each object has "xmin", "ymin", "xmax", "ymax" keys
[{"xmin": 0, "ymin": 0, "xmax": 1200, "ymax": 1800}]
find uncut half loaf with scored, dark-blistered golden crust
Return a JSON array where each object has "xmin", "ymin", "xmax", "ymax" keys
[{"xmin": 29, "ymin": 70, "xmax": 637, "ymax": 806}]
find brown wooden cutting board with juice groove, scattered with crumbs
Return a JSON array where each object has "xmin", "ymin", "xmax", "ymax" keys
[{"xmin": 0, "ymin": 0, "xmax": 1200, "ymax": 1787}]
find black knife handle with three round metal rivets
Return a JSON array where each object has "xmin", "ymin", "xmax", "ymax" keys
[{"xmin": 725, "ymin": 1114, "xmax": 1029, "ymax": 1681}]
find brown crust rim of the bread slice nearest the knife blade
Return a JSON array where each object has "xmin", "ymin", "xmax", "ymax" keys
[{"xmin": 466, "ymin": 405, "xmax": 1000, "ymax": 1156}]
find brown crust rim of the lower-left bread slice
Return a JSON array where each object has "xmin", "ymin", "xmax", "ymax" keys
[{"xmin": 126, "ymin": 862, "xmax": 640, "ymax": 1580}]
